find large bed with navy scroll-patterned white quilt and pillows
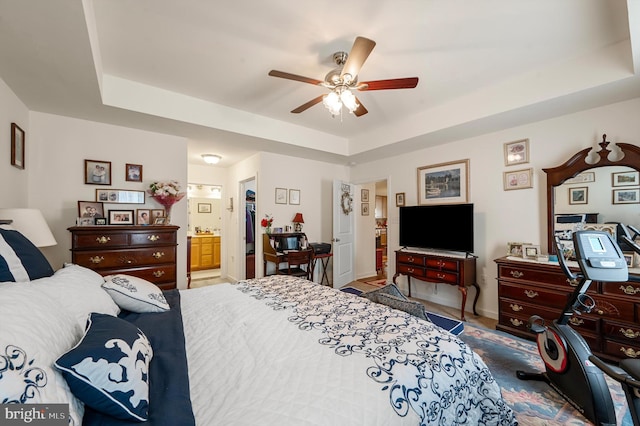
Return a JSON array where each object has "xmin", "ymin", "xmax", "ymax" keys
[{"xmin": 0, "ymin": 228, "xmax": 517, "ymax": 426}]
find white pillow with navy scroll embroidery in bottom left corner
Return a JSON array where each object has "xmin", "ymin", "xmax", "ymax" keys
[{"xmin": 0, "ymin": 283, "xmax": 84, "ymax": 425}]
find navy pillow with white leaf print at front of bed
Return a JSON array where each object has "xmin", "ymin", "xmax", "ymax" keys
[{"xmin": 55, "ymin": 313, "xmax": 153, "ymax": 421}]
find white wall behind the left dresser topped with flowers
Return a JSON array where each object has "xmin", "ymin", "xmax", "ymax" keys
[{"xmin": 27, "ymin": 112, "xmax": 187, "ymax": 288}]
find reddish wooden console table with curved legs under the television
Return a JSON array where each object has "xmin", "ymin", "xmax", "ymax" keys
[{"xmin": 393, "ymin": 250, "xmax": 480, "ymax": 321}]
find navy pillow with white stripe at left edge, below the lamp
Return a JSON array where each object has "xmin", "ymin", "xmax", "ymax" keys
[{"xmin": 0, "ymin": 228, "xmax": 53, "ymax": 282}]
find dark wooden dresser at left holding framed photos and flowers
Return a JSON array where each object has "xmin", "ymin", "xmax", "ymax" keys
[{"xmin": 69, "ymin": 225, "xmax": 179, "ymax": 290}]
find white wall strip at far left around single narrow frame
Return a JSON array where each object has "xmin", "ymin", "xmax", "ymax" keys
[{"xmin": 0, "ymin": 79, "xmax": 29, "ymax": 208}]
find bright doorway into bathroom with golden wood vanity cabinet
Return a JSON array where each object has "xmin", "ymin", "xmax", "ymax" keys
[{"xmin": 187, "ymin": 183, "xmax": 222, "ymax": 281}]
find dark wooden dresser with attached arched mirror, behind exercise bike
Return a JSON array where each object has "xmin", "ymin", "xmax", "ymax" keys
[{"xmin": 495, "ymin": 135, "xmax": 640, "ymax": 361}]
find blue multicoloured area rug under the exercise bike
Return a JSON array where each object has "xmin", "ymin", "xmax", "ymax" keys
[{"xmin": 460, "ymin": 324, "xmax": 633, "ymax": 426}]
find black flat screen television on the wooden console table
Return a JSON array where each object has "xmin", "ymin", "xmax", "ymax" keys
[{"xmin": 399, "ymin": 204, "xmax": 473, "ymax": 253}]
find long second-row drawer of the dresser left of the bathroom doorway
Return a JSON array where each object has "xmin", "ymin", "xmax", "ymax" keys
[{"xmin": 73, "ymin": 246, "xmax": 176, "ymax": 269}]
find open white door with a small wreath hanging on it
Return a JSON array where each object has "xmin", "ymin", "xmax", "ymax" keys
[{"xmin": 333, "ymin": 180, "xmax": 355, "ymax": 288}]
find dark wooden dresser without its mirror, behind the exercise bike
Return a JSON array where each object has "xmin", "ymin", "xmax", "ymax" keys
[{"xmin": 495, "ymin": 257, "xmax": 640, "ymax": 361}]
